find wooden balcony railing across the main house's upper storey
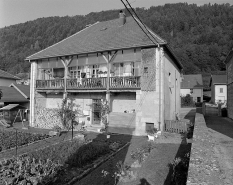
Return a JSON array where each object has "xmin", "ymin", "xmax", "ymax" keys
[{"xmin": 36, "ymin": 76, "xmax": 140, "ymax": 90}]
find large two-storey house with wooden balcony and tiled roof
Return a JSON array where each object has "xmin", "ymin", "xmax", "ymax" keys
[{"xmin": 26, "ymin": 13, "xmax": 182, "ymax": 135}]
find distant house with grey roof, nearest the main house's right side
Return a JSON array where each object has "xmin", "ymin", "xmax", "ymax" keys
[{"xmin": 180, "ymin": 74, "xmax": 203, "ymax": 102}]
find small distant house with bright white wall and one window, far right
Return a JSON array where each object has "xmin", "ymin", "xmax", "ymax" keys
[{"xmin": 210, "ymin": 75, "xmax": 227, "ymax": 103}]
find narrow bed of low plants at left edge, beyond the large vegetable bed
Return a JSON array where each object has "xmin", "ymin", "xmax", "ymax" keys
[{"xmin": 0, "ymin": 130, "xmax": 49, "ymax": 152}]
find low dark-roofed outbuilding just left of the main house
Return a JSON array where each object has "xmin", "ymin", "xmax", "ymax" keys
[{"xmin": 0, "ymin": 84, "xmax": 30, "ymax": 109}]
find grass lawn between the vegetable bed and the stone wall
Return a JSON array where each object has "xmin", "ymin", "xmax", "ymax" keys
[{"xmin": 75, "ymin": 134, "xmax": 191, "ymax": 185}]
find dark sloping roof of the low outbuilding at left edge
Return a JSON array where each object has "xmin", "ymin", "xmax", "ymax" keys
[{"xmin": 0, "ymin": 86, "xmax": 29, "ymax": 103}]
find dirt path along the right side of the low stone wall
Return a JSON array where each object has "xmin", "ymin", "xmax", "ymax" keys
[{"xmin": 205, "ymin": 115, "xmax": 233, "ymax": 184}]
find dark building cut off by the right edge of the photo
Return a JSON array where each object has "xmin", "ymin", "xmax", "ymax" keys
[{"xmin": 225, "ymin": 49, "xmax": 233, "ymax": 119}]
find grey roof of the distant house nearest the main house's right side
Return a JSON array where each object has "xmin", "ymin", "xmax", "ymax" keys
[{"xmin": 181, "ymin": 74, "xmax": 203, "ymax": 89}]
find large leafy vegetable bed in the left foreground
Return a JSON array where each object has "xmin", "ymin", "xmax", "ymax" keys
[{"xmin": 0, "ymin": 133, "xmax": 126, "ymax": 185}]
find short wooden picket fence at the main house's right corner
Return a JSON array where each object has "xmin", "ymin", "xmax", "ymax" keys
[{"xmin": 164, "ymin": 120, "xmax": 190, "ymax": 133}]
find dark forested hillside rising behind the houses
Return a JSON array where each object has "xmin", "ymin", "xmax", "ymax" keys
[{"xmin": 0, "ymin": 3, "xmax": 233, "ymax": 74}]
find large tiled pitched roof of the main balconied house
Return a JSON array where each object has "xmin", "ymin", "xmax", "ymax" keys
[{"xmin": 26, "ymin": 17, "xmax": 166, "ymax": 60}]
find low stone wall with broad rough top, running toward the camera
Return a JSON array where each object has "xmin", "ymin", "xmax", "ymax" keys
[{"xmin": 187, "ymin": 113, "xmax": 223, "ymax": 185}]
